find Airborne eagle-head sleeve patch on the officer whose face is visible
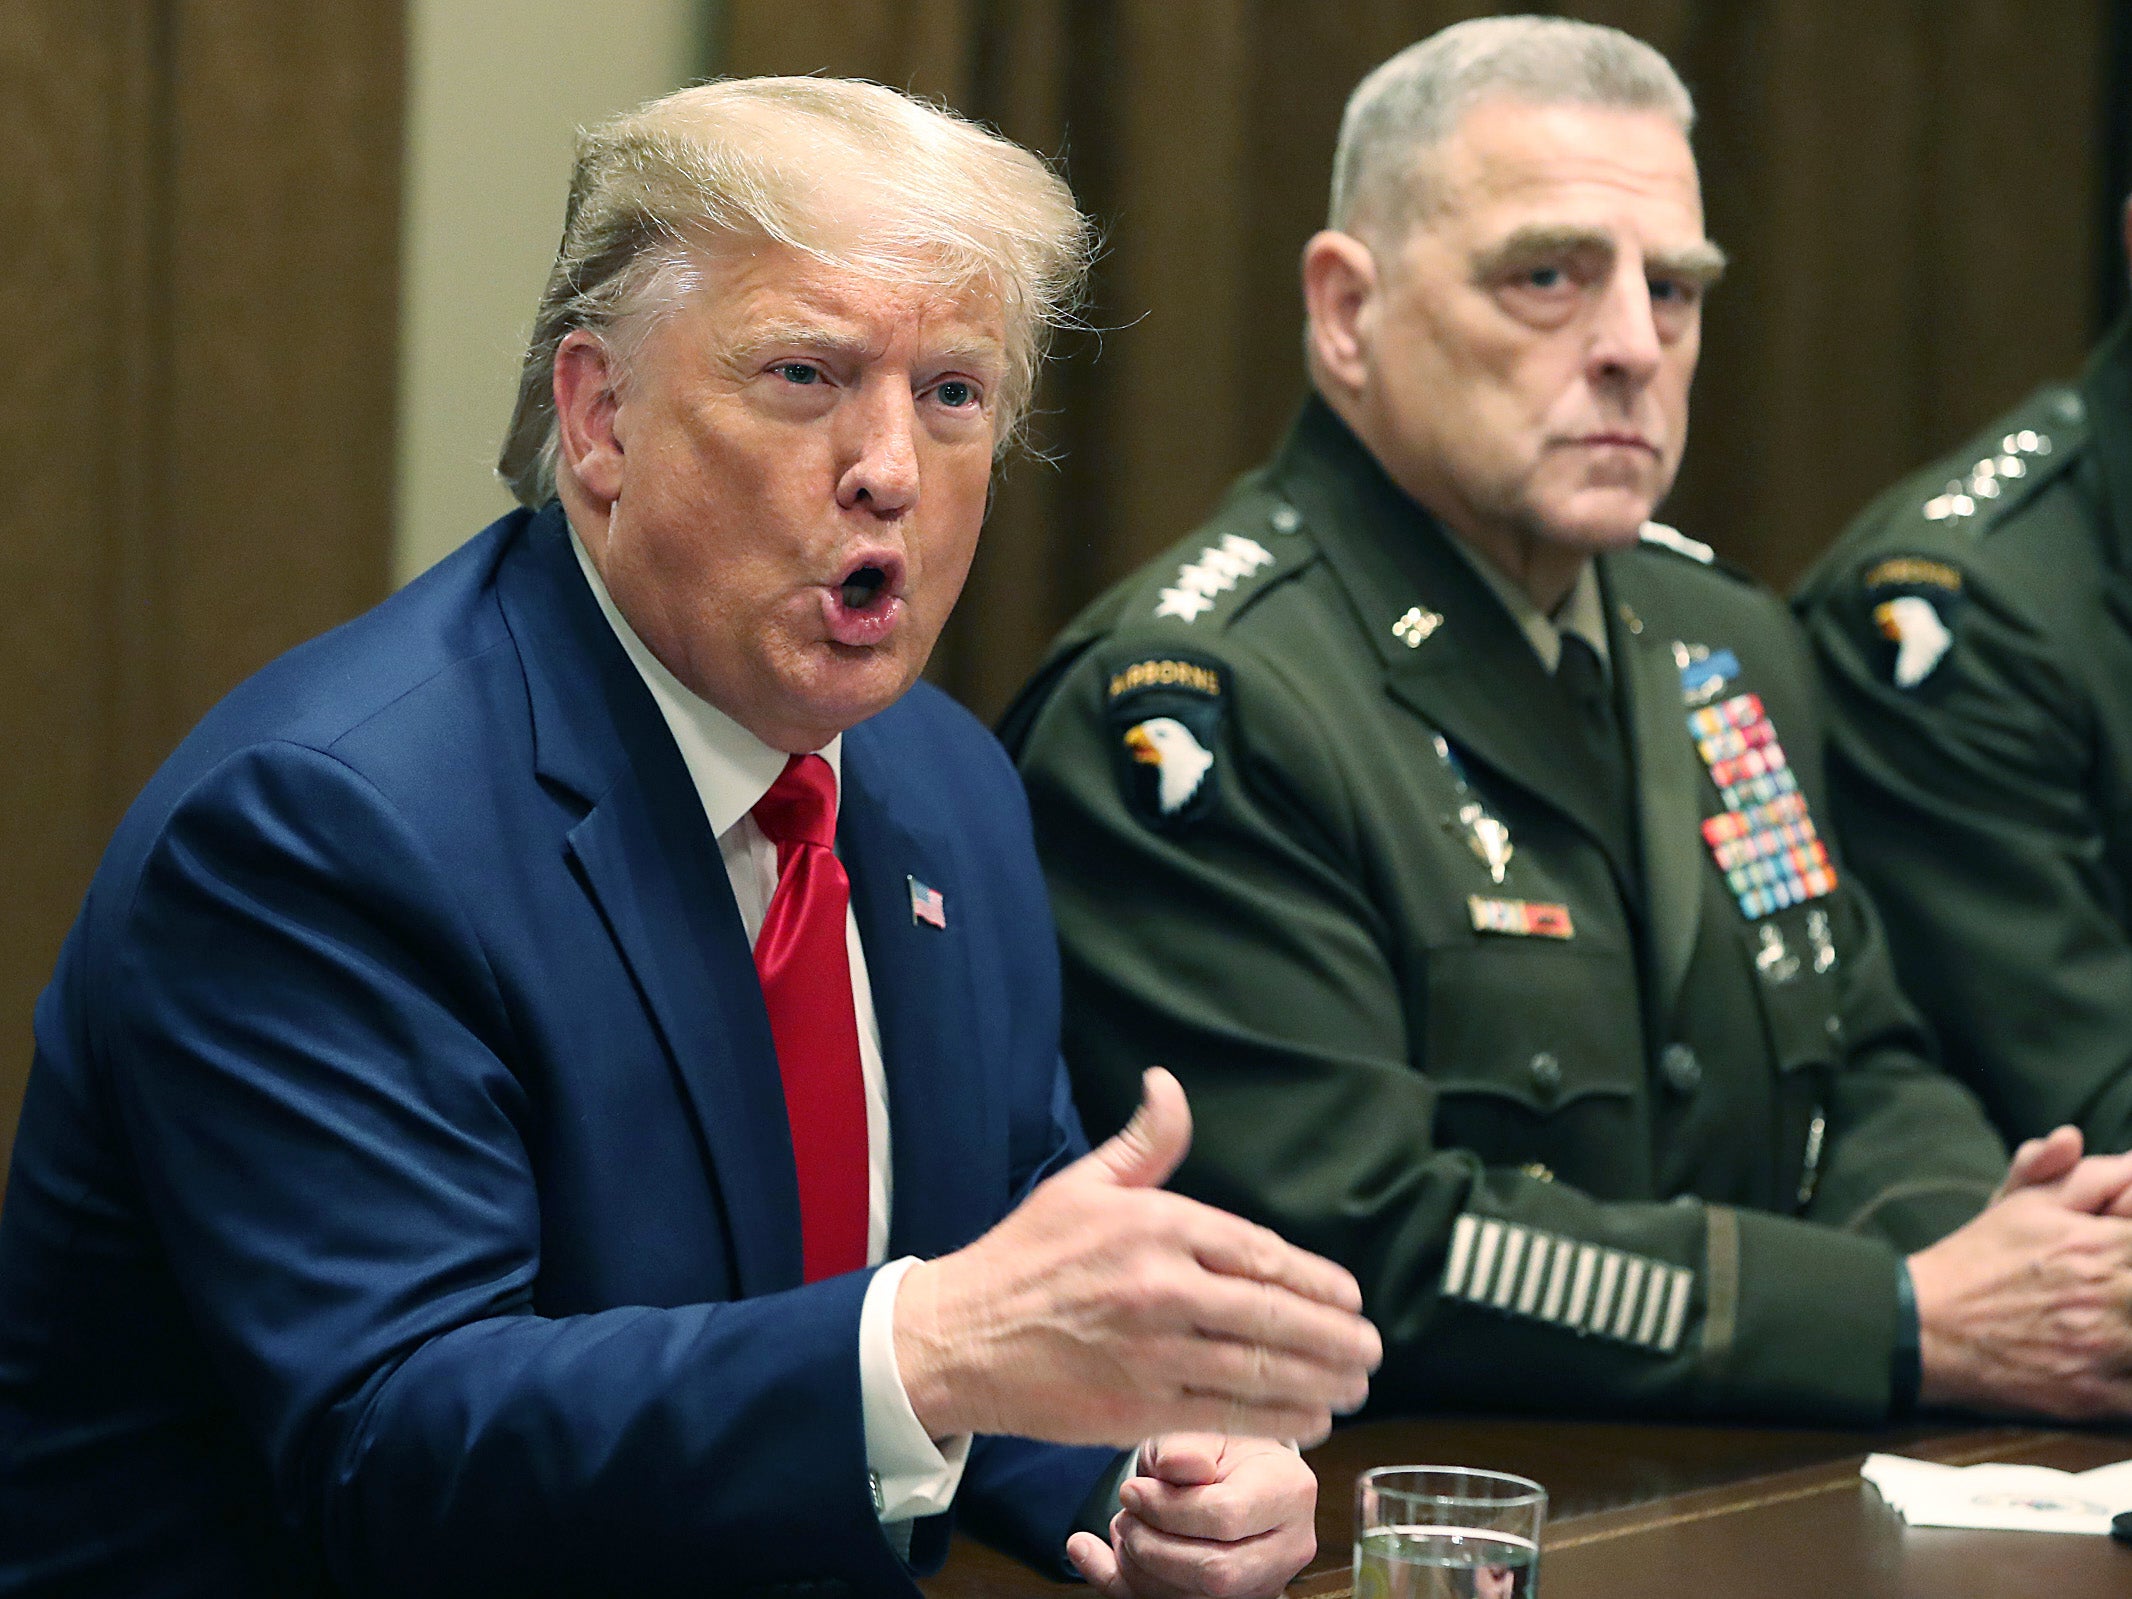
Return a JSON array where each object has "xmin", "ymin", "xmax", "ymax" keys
[{"xmin": 1102, "ymin": 650, "xmax": 1228, "ymax": 831}]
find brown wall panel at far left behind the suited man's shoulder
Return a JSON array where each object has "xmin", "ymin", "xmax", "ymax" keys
[{"xmin": 0, "ymin": 0, "xmax": 401, "ymax": 1193}]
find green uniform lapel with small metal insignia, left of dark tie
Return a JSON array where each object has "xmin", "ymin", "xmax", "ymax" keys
[{"xmin": 1275, "ymin": 399, "xmax": 1637, "ymax": 904}]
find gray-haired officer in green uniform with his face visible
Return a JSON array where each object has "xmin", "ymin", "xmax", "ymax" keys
[{"xmin": 1006, "ymin": 17, "xmax": 2132, "ymax": 1424}]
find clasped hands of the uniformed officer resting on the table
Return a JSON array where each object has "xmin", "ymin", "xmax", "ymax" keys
[{"xmin": 1910, "ymin": 1128, "xmax": 2132, "ymax": 1420}]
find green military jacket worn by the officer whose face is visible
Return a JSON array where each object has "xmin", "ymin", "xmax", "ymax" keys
[{"xmin": 1002, "ymin": 401, "xmax": 2004, "ymax": 1422}]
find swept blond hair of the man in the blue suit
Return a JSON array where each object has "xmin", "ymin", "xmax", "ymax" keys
[{"xmin": 497, "ymin": 77, "xmax": 1094, "ymax": 507}]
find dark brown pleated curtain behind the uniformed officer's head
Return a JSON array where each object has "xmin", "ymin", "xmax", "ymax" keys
[{"xmin": 723, "ymin": 0, "xmax": 2109, "ymax": 716}]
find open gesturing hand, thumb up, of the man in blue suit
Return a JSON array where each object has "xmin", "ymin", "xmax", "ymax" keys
[{"xmin": 895, "ymin": 1068, "xmax": 1382, "ymax": 1448}]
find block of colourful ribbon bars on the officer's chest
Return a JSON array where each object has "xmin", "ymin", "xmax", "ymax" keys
[{"xmin": 1689, "ymin": 695, "xmax": 1836, "ymax": 921}]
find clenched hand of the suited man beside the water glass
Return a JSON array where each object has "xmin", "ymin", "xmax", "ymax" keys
[{"xmin": 1066, "ymin": 1433, "xmax": 1318, "ymax": 1599}]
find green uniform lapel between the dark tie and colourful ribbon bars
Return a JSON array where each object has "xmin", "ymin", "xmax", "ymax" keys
[{"xmin": 1599, "ymin": 556, "xmax": 1703, "ymax": 1017}]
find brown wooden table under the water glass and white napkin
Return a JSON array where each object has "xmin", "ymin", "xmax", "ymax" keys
[{"xmin": 925, "ymin": 1418, "xmax": 2132, "ymax": 1599}]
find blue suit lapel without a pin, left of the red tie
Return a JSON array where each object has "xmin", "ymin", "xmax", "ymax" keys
[{"xmin": 503, "ymin": 507, "xmax": 802, "ymax": 1294}]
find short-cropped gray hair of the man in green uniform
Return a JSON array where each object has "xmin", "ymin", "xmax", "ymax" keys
[{"xmin": 1326, "ymin": 17, "xmax": 1695, "ymax": 243}]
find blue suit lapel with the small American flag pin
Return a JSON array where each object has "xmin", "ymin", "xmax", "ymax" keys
[{"xmin": 838, "ymin": 723, "xmax": 1006, "ymax": 1256}]
